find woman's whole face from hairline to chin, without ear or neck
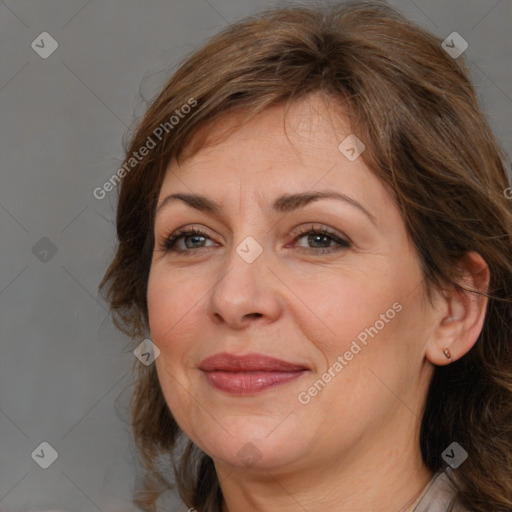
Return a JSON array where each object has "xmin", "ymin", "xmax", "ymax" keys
[{"xmin": 148, "ymin": 95, "xmax": 433, "ymax": 478}]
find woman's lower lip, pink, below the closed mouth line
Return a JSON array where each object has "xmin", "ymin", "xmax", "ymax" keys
[{"xmin": 203, "ymin": 370, "xmax": 306, "ymax": 395}]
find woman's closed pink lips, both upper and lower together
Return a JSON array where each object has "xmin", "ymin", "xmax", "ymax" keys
[{"xmin": 199, "ymin": 352, "xmax": 308, "ymax": 395}]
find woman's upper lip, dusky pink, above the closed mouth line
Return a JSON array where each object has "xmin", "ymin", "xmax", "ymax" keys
[{"xmin": 199, "ymin": 352, "xmax": 308, "ymax": 372}]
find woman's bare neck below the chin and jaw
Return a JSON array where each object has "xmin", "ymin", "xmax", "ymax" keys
[{"xmin": 215, "ymin": 418, "xmax": 433, "ymax": 512}]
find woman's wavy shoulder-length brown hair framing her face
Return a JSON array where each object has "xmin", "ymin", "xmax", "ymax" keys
[{"xmin": 100, "ymin": 2, "xmax": 512, "ymax": 512}]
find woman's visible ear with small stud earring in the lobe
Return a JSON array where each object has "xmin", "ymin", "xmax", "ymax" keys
[{"xmin": 425, "ymin": 252, "xmax": 490, "ymax": 366}]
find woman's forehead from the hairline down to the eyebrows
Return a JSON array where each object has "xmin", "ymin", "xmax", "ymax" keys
[{"xmin": 154, "ymin": 97, "xmax": 399, "ymax": 237}]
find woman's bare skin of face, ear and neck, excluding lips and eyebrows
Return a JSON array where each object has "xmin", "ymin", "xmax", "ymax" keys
[{"xmin": 147, "ymin": 94, "xmax": 489, "ymax": 512}]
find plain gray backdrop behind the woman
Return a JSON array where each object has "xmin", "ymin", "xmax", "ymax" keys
[{"xmin": 0, "ymin": 0, "xmax": 512, "ymax": 512}]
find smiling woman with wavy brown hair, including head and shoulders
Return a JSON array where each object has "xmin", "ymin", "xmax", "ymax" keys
[{"xmin": 101, "ymin": 2, "xmax": 512, "ymax": 512}]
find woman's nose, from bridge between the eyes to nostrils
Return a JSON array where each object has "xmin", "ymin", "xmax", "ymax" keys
[{"xmin": 208, "ymin": 242, "xmax": 283, "ymax": 329}]
